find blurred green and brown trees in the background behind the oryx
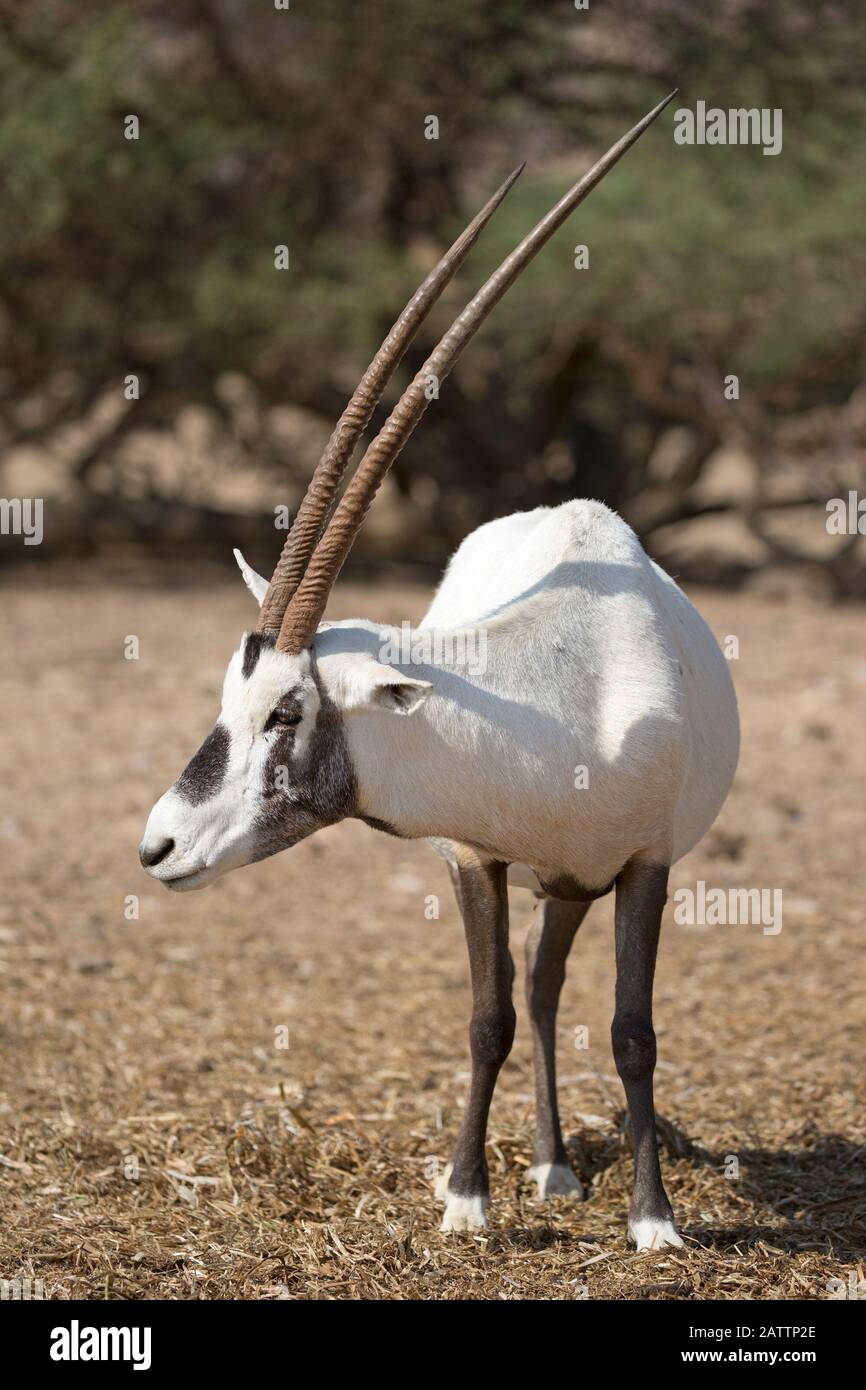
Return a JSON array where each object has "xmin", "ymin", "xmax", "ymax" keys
[{"xmin": 0, "ymin": 0, "xmax": 866, "ymax": 591}]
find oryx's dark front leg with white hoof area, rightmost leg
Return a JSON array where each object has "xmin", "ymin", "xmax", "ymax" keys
[{"xmin": 610, "ymin": 860, "xmax": 683, "ymax": 1250}]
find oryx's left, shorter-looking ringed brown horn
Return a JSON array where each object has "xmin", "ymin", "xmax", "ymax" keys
[{"xmin": 259, "ymin": 164, "xmax": 524, "ymax": 632}]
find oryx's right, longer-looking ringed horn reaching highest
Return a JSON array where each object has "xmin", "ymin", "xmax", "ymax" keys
[{"xmin": 277, "ymin": 90, "xmax": 677, "ymax": 652}]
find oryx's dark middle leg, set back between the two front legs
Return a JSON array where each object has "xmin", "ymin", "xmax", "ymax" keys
[{"xmin": 525, "ymin": 898, "xmax": 589, "ymax": 1197}]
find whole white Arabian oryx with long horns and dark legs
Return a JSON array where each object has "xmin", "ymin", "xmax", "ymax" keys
[{"xmin": 140, "ymin": 93, "xmax": 738, "ymax": 1250}]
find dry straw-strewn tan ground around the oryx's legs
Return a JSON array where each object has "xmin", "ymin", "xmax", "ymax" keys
[{"xmin": 0, "ymin": 577, "xmax": 866, "ymax": 1300}]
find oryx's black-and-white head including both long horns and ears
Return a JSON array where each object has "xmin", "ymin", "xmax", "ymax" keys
[{"xmin": 139, "ymin": 93, "xmax": 676, "ymax": 890}]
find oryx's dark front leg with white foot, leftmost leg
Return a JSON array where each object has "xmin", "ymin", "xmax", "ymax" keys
[{"xmin": 438, "ymin": 845, "xmax": 514, "ymax": 1230}]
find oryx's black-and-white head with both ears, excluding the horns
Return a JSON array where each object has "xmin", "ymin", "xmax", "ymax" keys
[{"xmin": 139, "ymin": 552, "xmax": 430, "ymax": 891}]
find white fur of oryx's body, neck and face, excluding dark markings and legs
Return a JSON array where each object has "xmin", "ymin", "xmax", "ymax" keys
[{"xmin": 142, "ymin": 502, "xmax": 738, "ymax": 895}]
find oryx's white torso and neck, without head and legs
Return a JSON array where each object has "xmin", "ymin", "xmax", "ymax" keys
[{"xmin": 325, "ymin": 502, "xmax": 738, "ymax": 890}]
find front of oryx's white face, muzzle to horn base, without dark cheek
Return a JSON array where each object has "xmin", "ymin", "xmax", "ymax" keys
[{"xmin": 140, "ymin": 634, "xmax": 321, "ymax": 891}]
